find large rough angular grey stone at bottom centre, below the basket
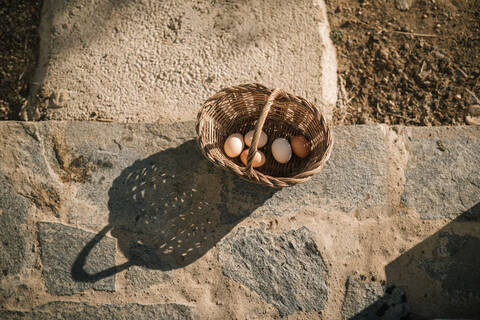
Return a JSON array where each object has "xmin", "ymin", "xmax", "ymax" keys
[{"xmin": 220, "ymin": 228, "xmax": 328, "ymax": 315}]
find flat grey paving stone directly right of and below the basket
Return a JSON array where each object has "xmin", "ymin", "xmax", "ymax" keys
[{"xmin": 255, "ymin": 125, "xmax": 387, "ymax": 215}]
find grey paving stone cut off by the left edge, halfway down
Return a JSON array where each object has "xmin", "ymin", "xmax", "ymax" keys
[{"xmin": 0, "ymin": 175, "xmax": 33, "ymax": 279}]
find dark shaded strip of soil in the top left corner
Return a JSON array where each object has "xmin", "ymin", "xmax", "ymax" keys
[{"xmin": 0, "ymin": 0, "xmax": 42, "ymax": 120}]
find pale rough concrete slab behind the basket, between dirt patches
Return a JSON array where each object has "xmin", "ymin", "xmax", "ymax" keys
[{"xmin": 28, "ymin": 0, "xmax": 337, "ymax": 122}]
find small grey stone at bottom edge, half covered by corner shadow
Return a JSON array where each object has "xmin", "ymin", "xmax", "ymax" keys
[{"xmin": 342, "ymin": 276, "xmax": 409, "ymax": 320}]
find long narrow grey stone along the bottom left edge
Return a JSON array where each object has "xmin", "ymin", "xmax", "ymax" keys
[{"xmin": 0, "ymin": 301, "xmax": 194, "ymax": 320}]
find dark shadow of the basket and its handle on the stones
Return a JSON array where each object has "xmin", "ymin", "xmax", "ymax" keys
[{"xmin": 71, "ymin": 140, "xmax": 276, "ymax": 282}]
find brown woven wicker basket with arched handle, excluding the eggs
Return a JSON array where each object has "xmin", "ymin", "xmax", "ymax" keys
[{"xmin": 196, "ymin": 83, "xmax": 333, "ymax": 188}]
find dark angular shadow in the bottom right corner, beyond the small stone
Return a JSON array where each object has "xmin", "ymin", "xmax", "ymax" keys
[{"xmin": 385, "ymin": 202, "xmax": 480, "ymax": 319}]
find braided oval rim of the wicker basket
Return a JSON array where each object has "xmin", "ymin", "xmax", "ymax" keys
[{"xmin": 195, "ymin": 83, "xmax": 334, "ymax": 188}]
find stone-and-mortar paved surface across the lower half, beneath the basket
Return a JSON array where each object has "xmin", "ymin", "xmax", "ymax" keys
[{"xmin": 0, "ymin": 121, "xmax": 480, "ymax": 319}]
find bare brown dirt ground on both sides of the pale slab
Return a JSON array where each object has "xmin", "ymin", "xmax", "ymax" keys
[{"xmin": 0, "ymin": 0, "xmax": 480, "ymax": 126}]
